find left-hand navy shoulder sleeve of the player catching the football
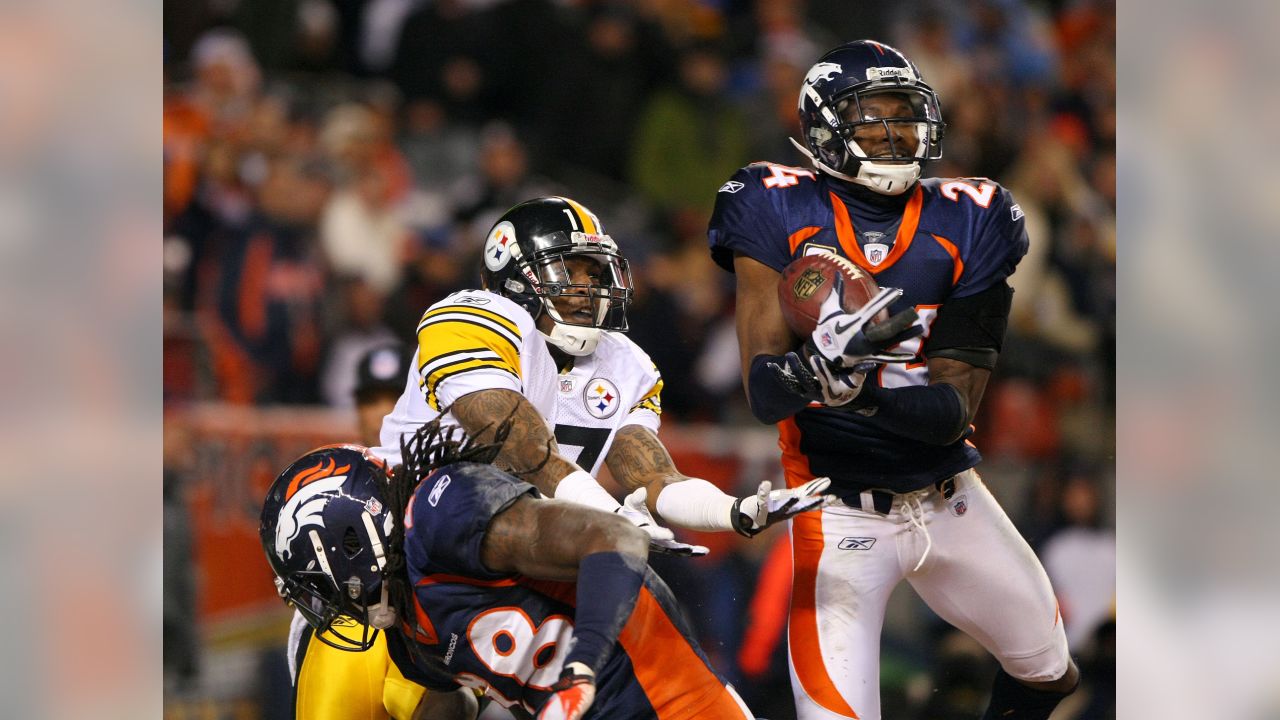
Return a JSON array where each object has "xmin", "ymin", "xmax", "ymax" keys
[{"xmin": 707, "ymin": 167, "xmax": 791, "ymax": 273}]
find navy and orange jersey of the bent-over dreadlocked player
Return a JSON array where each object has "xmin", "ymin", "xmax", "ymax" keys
[{"xmin": 404, "ymin": 464, "xmax": 750, "ymax": 720}]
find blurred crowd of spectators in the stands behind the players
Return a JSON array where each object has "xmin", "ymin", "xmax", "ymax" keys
[{"xmin": 164, "ymin": 0, "xmax": 1116, "ymax": 719}]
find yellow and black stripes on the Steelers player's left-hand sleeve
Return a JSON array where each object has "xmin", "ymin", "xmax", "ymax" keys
[{"xmin": 417, "ymin": 304, "xmax": 521, "ymax": 411}]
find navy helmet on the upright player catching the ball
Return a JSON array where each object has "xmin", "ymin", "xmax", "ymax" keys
[{"xmin": 791, "ymin": 40, "xmax": 946, "ymax": 195}]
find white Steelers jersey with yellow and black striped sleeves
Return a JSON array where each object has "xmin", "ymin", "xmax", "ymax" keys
[{"xmin": 374, "ymin": 290, "xmax": 662, "ymax": 475}]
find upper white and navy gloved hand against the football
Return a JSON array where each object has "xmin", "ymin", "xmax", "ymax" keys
[{"xmin": 805, "ymin": 274, "xmax": 924, "ymax": 369}]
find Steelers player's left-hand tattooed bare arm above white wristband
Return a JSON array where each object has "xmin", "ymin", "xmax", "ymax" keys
[{"xmin": 451, "ymin": 389, "xmax": 581, "ymax": 497}]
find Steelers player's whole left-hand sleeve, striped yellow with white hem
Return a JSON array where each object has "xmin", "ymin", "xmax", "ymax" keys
[{"xmin": 417, "ymin": 297, "xmax": 524, "ymax": 411}]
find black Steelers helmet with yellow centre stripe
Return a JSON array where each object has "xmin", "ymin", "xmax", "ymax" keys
[{"xmin": 481, "ymin": 197, "xmax": 631, "ymax": 356}]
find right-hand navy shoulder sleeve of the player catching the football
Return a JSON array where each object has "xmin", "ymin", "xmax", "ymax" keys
[{"xmin": 951, "ymin": 184, "xmax": 1030, "ymax": 299}]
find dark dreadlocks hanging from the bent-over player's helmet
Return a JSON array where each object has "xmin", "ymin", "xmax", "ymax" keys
[{"xmin": 384, "ymin": 407, "xmax": 519, "ymax": 669}]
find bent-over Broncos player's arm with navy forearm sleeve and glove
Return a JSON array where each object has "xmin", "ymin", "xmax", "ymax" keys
[{"xmin": 480, "ymin": 497, "xmax": 649, "ymax": 720}]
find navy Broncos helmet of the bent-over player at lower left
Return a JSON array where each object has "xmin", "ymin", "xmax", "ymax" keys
[{"xmin": 259, "ymin": 445, "xmax": 396, "ymax": 651}]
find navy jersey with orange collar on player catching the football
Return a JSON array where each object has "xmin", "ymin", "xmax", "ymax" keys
[{"xmin": 708, "ymin": 163, "xmax": 1028, "ymax": 493}]
